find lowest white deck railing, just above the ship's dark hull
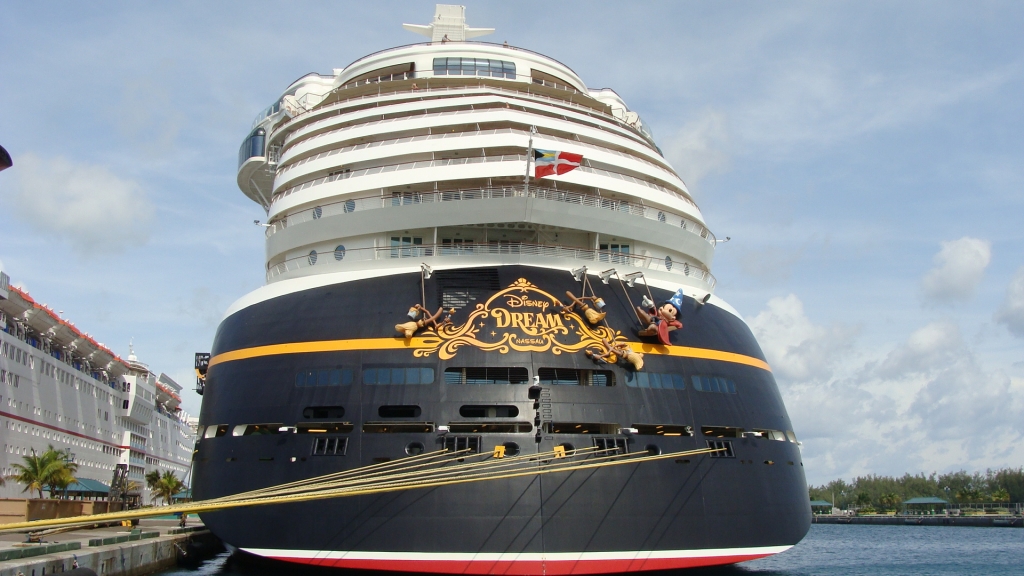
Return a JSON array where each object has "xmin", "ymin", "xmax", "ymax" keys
[{"xmin": 266, "ymin": 242, "xmax": 716, "ymax": 291}]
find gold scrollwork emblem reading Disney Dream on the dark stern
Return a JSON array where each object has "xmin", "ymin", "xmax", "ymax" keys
[{"xmin": 413, "ymin": 278, "xmax": 626, "ymax": 360}]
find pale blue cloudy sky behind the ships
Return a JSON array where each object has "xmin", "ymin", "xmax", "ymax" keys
[{"xmin": 0, "ymin": 2, "xmax": 1024, "ymax": 483}]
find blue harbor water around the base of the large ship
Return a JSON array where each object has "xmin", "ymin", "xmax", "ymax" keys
[{"xmin": 161, "ymin": 524, "xmax": 1024, "ymax": 576}]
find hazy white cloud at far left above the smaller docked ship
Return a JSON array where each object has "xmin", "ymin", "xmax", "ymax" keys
[{"xmin": 10, "ymin": 154, "xmax": 153, "ymax": 253}]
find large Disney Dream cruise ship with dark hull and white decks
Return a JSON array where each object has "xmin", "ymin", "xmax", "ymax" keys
[{"xmin": 194, "ymin": 5, "xmax": 811, "ymax": 574}]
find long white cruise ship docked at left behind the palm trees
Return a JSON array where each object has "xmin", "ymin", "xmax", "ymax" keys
[{"xmin": 0, "ymin": 271, "xmax": 195, "ymax": 505}]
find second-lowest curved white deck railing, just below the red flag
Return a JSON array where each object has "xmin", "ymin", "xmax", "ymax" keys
[{"xmin": 266, "ymin": 186, "xmax": 717, "ymax": 246}]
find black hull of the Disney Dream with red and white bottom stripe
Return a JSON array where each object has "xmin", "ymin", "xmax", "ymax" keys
[{"xmin": 194, "ymin": 266, "xmax": 811, "ymax": 574}]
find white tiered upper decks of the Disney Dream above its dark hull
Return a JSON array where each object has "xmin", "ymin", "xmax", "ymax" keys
[{"xmin": 238, "ymin": 5, "xmax": 716, "ymax": 299}]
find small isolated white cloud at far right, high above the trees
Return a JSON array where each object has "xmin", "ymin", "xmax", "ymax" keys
[{"xmin": 922, "ymin": 236, "xmax": 992, "ymax": 301}]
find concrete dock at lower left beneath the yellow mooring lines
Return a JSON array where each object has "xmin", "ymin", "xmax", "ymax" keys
[{"xmin": 0, "ymin": 519, "xmax": 219, "ymax": 576}]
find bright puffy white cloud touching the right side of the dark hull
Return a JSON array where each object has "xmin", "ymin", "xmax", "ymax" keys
[{"xmin": 749, "ymin": 294, "xmax": 854, "ymax": 380}]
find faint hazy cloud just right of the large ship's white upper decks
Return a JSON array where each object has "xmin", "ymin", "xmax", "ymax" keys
[{"xmin": 665, "ymin": 109, "xmax": 729, "ymax": 188}]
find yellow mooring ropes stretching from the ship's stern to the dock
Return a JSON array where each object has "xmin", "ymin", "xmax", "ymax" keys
[{"xmin": 0, "ymin": 447, "xmax": 722, "ymax": 533}]
